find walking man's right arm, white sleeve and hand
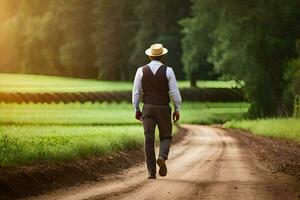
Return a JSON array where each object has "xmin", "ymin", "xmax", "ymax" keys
[{"xmin": 167, "ymin": 68, "xmax": 182, "ymax": 122}]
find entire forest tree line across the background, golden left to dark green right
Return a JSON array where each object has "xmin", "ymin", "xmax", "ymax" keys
[{"xmin": 0, "ymin": 0, "xmax": 300, "ymax": 117}]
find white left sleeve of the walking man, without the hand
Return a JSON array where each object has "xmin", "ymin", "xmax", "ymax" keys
[{"xmin": 132, "ymin": 68, "xmax": 143, "ymax": 115}]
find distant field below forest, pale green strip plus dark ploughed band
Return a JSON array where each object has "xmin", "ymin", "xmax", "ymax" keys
[{"xmin": 0, "ymin": 73, "xmax": 244, "ymax": 103}]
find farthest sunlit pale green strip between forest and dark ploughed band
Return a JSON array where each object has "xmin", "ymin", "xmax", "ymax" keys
[{"xmin": 0, "ymin": 73, "xmax": 237, "ymax": 92}]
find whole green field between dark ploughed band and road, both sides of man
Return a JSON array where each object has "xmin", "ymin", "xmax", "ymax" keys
[{"xmin": 0, "ymin": 103, "xmax": 249, "ymax": 166}]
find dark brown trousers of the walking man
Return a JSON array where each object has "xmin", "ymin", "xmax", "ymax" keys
[{"xmin": 142, "ymin": 104, "xmax": 172, "ymax": 175}]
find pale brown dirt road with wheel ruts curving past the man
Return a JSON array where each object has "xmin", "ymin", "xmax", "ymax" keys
[{"xmin": 30, "ymin": 125, "xmax": 300, "ymax": 200}]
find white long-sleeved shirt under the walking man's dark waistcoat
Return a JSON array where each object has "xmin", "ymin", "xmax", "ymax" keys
[{"xmin": 132, "ymin": 60, "xmax": 182, "ymax": 111}]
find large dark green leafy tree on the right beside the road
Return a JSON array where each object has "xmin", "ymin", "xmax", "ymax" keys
[{"xmin": 183, "ymin": 0, "xmax": 300, "ymax": 117}]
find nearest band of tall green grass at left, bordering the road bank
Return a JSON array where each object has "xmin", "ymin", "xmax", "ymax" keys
[{"xmin": 0, "ymin": 126, "xmax": 144, "ymax": 166}]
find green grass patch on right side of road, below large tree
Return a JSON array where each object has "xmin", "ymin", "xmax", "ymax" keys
[{"xmin": 224, "ymin": 118, "xmax": 300, "ymax": 143}]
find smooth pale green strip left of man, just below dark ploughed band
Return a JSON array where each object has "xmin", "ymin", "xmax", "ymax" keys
[{"xmin": 0, "ymin": 102, "xmax": 138, "ymax": 125}]
